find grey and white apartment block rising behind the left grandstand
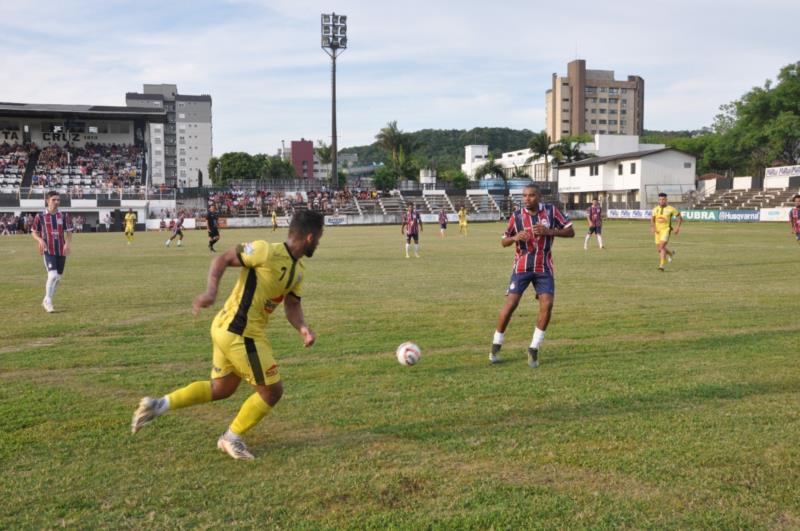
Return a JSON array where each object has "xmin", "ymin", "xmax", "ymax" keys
[{"xmin": 125, "ymin": 84, "xmax": 213, "ymax": 188}]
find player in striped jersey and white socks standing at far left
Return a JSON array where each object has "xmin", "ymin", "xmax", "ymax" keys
[{"xmin": 31, "ymin": 191, "xmax": 73, "ymax": 313}]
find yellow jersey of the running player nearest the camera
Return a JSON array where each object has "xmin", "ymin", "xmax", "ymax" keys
[{"xmin": 212, "ymin": 240, "xmax": 305, "ymax": 339}]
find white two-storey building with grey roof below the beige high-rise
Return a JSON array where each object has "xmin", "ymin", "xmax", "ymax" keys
[{"xmin": 558, "ymin": 135, "xmax": 697, "ymax": 209}]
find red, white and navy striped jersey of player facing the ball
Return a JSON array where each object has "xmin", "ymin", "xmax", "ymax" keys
[{"xmin": 503, "ymin": 203, "xmax": 572, "ymax": 275}]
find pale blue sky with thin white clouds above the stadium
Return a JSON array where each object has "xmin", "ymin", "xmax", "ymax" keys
[{"xmin": 0, "ymin": 0, "xmax": 800, "ymax": 156}]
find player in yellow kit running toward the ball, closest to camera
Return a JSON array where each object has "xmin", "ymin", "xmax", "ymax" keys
[{"xmin": 131, "ymin": 210, "xmax": 324, "ymax": 459}]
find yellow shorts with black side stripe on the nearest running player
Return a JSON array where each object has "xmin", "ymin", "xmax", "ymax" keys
[{"xmin": 211, "ymin": 326, "xmax": 281, "ymax": 385}]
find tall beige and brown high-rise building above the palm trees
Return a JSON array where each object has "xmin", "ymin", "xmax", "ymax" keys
[{"xmin": 545, "ymin": 59, "xmax": 644, "ymax": 141}]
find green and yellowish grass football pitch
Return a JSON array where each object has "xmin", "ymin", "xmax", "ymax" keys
[{"xmin": 0, "ymin": 222, "xmax": 800, "ymax": 529}]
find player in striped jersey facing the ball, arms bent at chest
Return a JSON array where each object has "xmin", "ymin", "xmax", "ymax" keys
[{"xmin": 489, "ymin": 184, "xmax": 575, "ymax": 369}]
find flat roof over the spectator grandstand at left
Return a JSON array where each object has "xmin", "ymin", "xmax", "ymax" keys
[{"xmin": 0, "ymin": 102, "xmax": 167, "ymax": 122}]
